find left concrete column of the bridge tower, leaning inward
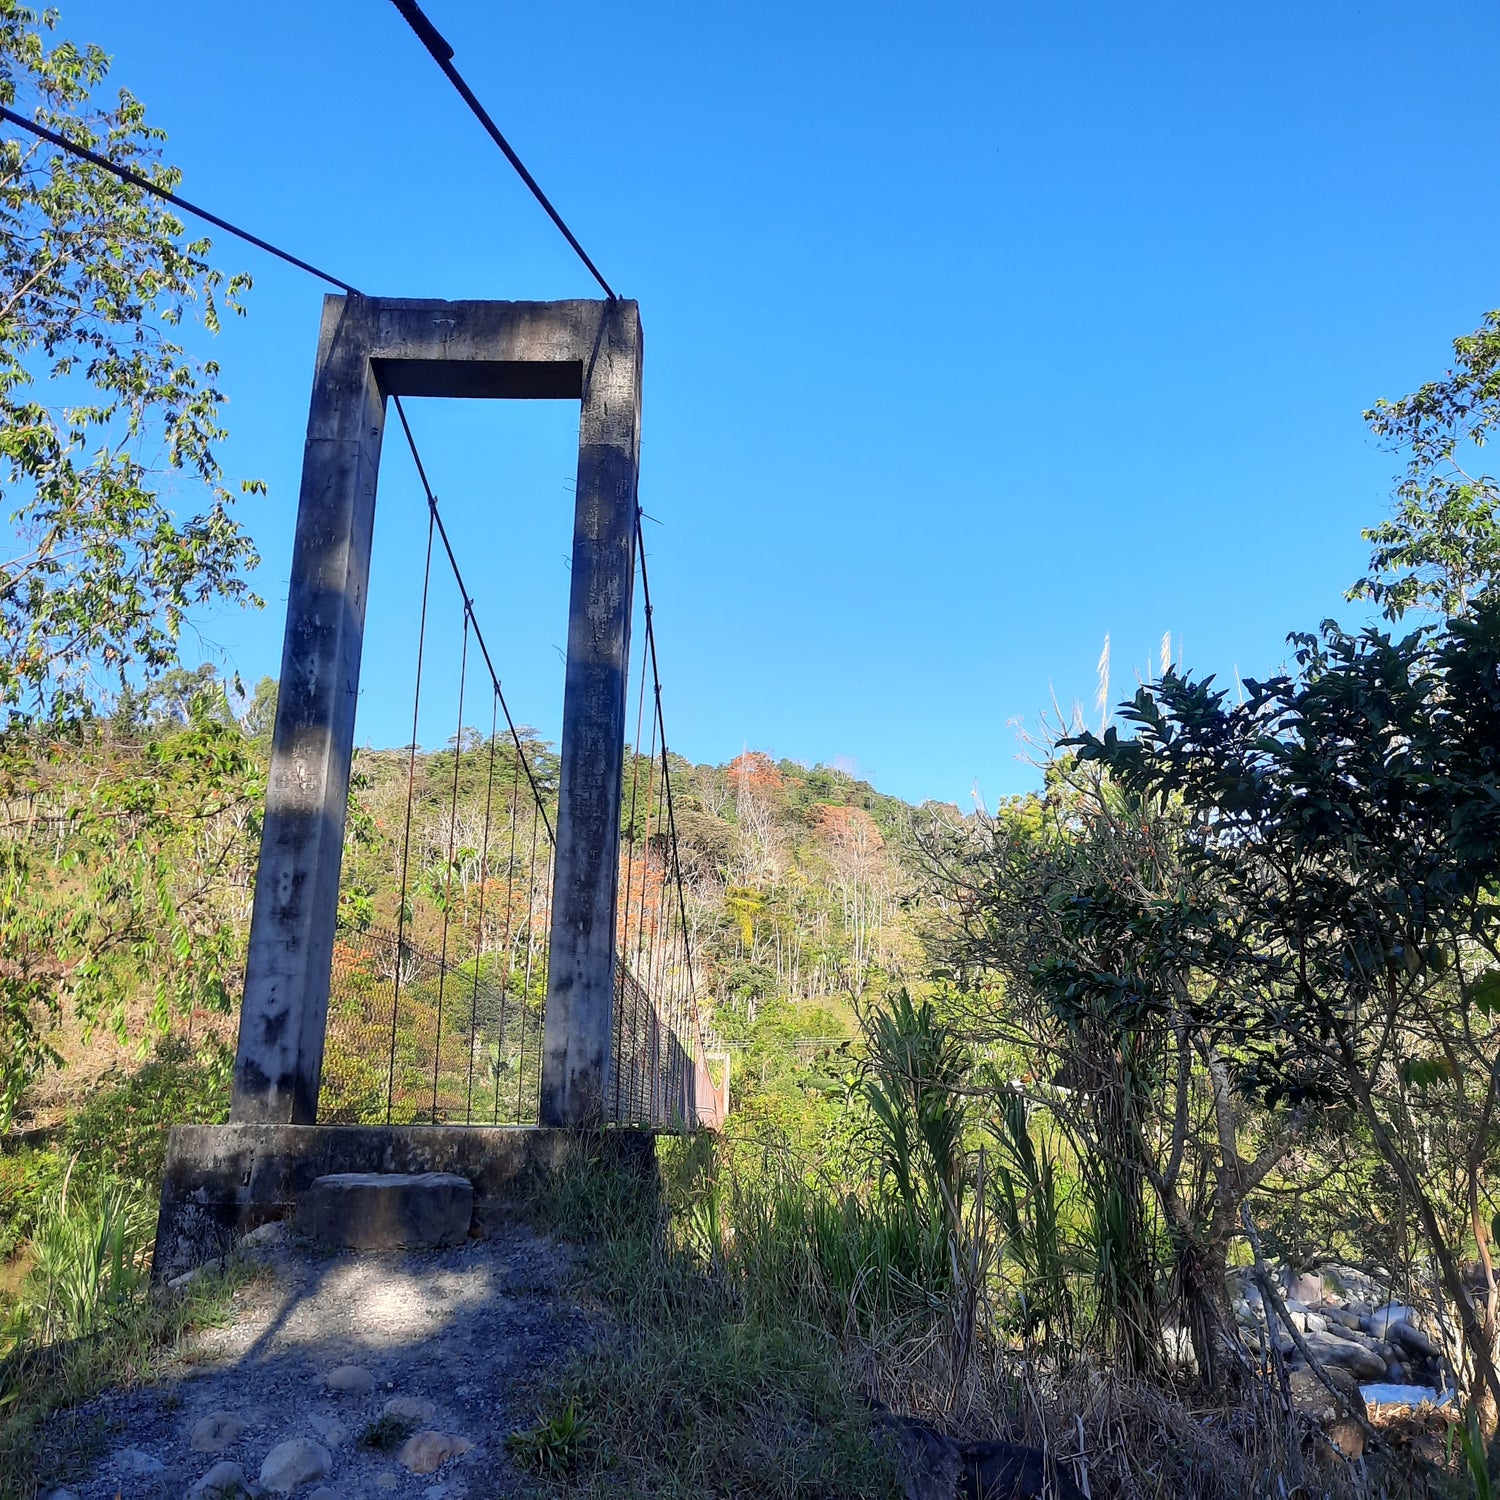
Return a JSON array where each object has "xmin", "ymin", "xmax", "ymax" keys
[{"xmin": 230, "ymin": 297, "xmax": 386, "ymax": 1125}]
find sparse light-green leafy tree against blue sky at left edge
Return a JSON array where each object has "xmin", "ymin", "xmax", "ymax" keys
[{"xmin": 0, "ymin": 0, "xmax": 263, "ymax": 722}]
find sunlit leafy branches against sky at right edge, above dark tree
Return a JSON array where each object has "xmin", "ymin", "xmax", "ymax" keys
[{"xmin": 1349, "ymin": 312, "xmax": 1500, "ymax": 620}]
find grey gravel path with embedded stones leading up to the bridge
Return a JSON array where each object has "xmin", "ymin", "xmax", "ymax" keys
[{"xmin": 39, "ymin": 1226, "xmax": 603, "ymax": 1500}]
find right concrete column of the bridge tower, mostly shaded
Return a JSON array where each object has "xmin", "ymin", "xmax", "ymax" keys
[{"xmin": 540, "ymin": 302, "xmax": 642, "ymax": 1127}]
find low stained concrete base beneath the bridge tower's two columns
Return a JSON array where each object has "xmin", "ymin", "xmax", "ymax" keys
[{"xmin": 152, "ymin": 1124, "xmax": 657, "ymax": 1283}]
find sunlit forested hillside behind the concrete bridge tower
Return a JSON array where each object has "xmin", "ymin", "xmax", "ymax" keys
[{"xmin": 6, "ymin": 696, "xmax": 921, "ymax": 1131}]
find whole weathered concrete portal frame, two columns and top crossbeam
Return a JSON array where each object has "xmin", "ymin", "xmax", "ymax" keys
[{"xmin": 230, "ymin": 296, "xmax": 641, "ymax": 1125}]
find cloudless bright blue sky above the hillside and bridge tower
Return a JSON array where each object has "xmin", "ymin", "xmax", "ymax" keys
[{"xmin": 52, "ymin": 0, "xmax": 1500, "ymax": 804}]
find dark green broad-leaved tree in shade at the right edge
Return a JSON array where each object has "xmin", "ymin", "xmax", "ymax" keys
[{"xmin": 1073, "ymin": 602, "xmax": 1500, "ymax": 1421}]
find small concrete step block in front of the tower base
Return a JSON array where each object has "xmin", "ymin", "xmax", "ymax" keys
[{"xmin": 296, "ymin": 1172, "xmax": 474, "ymax": 1250}]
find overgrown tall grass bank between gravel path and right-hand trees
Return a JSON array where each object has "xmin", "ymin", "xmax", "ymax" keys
[{"xmin": 512, "ymin": 993, "xmax": 1464, "ymax": 1500}]
